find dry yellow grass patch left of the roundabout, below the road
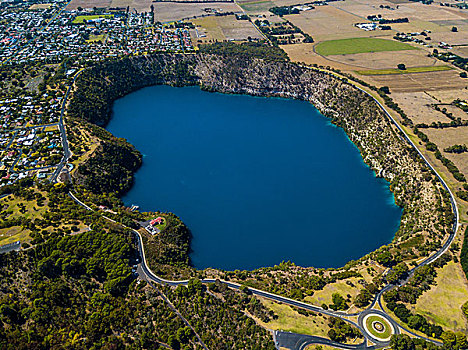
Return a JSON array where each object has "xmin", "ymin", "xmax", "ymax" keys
[{"xmin": 257, "ymin": 299, "xmax": 329, "ymax": 337}]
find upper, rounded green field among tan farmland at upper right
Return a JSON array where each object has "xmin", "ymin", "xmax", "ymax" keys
[{"xmin": 315, "ymin": 38, "xmax": 417, "ymax": 56}]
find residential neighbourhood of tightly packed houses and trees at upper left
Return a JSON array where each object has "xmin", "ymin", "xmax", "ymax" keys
[{"xmin": 0, "ymin": 0, "xmax": 194, "ymax": 187}]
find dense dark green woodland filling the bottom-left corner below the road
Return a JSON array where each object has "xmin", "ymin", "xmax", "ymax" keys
[{"xmin": 0, "ymin": 191, "xmax": 197, "ymax": 349}]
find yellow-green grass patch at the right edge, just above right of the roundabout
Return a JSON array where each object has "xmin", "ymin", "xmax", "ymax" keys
[{"xmin": 413, "ymin": 261, "xmax": 468, "ymax": 332}]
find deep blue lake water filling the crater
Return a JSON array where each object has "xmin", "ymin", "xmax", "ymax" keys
[{"xmin": 107, "ymin": 86, "xmax": 401, "ymax": 270}]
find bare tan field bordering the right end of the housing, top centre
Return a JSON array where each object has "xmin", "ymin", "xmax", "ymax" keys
[{"xmin": 192, "ymin": 15, "xmax": 262, "ymax": 43}]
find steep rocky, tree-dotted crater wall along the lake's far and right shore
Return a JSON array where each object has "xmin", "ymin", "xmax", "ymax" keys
[{"xmin": 71, "ymin": 54, "xmax": 450, "ymax": 255}]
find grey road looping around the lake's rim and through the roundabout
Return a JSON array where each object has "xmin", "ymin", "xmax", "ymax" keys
[{"xmin": 60, "ymin": 65, "xmax": 459, "ymax": 350}]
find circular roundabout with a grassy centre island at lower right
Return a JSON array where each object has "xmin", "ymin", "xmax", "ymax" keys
[{"xmin": 359, "ymin": 309, "xmax": 399, "ymax": 343}]
